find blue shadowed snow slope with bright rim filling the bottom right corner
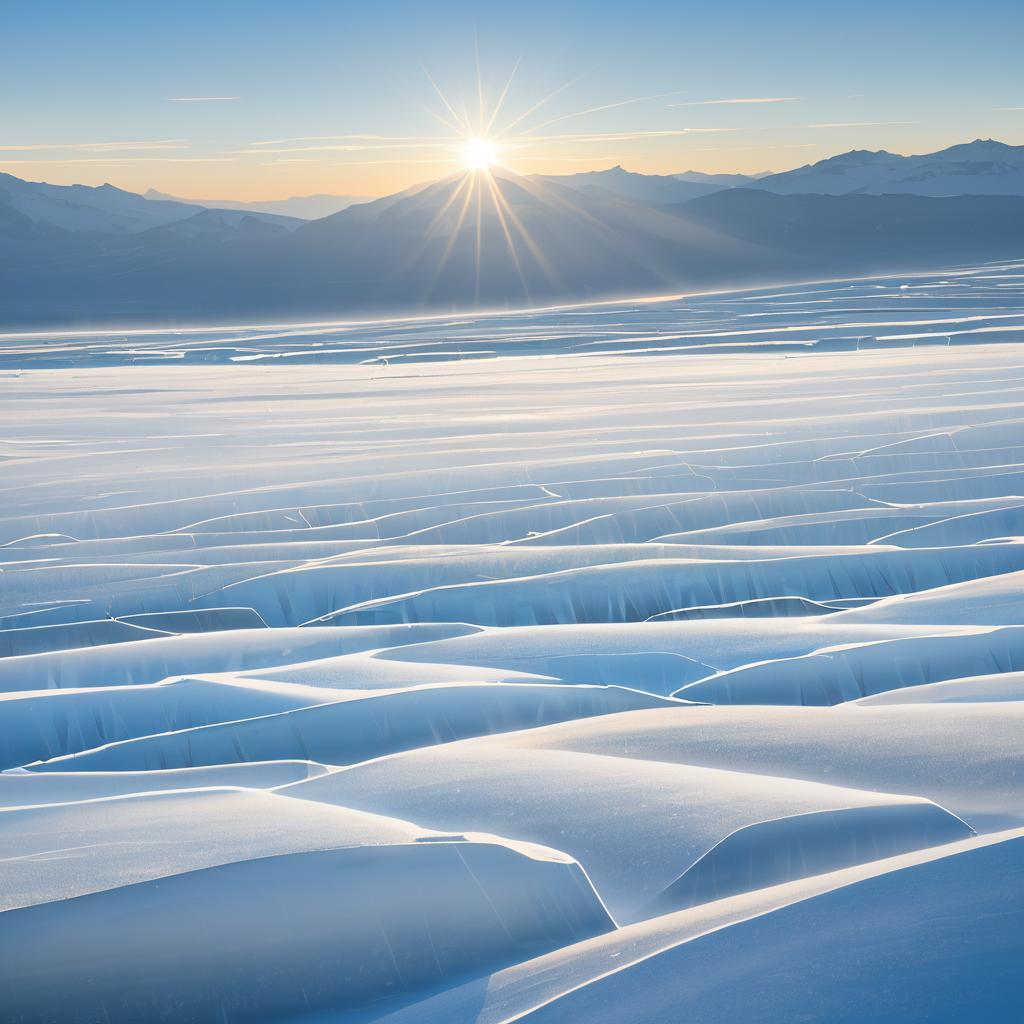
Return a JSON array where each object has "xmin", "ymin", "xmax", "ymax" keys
[{"xmin": 374, "ymin": 829, "xmax": 1024, "ymax": 1024}]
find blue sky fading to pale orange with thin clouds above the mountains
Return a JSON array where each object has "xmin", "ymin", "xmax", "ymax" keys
[{"xmin": 0, "ymin": 0, "xmax": 1024, "ymax": 201}]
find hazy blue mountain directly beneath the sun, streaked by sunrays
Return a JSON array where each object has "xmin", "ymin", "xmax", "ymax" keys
[{"xmin": 290, "ymin": 172, "xmax": 753, "ymax": 308}]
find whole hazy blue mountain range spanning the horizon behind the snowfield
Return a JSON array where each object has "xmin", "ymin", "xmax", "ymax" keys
[{"xmin": 0, "ymin": 140, "xmax": 1024, "ymax": 329}]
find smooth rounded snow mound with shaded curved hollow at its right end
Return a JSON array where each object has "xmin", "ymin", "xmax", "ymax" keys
[{"xmin": 278, "ymin": 730, "xmax": 969, "ymax": 920}]
